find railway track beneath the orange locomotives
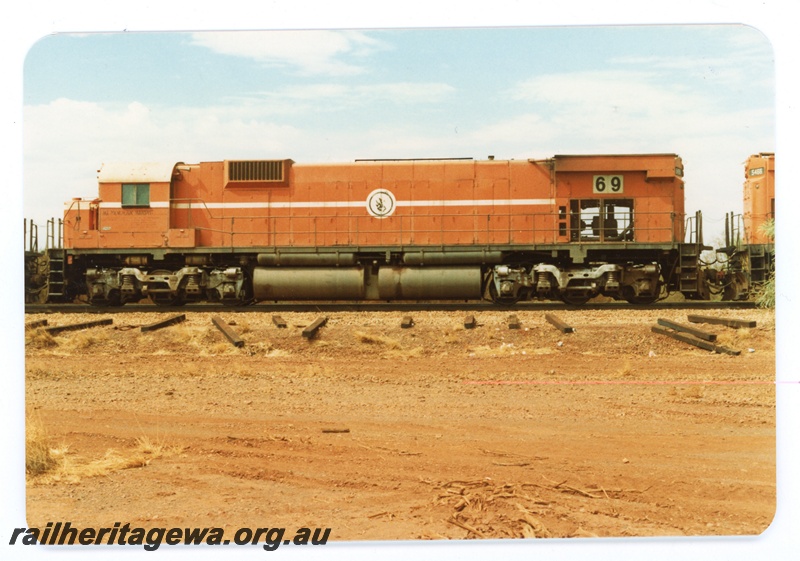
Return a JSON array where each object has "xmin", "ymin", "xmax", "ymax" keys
[{"xmin": 25, "ymin": 301, "xmax": 756, "ymax": 314}]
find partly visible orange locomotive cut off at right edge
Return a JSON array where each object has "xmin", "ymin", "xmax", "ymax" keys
[{"xmin": 718, "ymin": 152, "xmax": 775, "ymax": 300}]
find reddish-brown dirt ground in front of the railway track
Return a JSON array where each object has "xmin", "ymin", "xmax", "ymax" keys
[{"xmin": 25, "ymin": 310, "xmax": 776, "ymax": 541}]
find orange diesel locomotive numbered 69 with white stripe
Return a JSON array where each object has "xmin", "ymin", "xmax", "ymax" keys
[{"xmin": 50, "ymin": 154, "xmax": 708, "ymax": 304}]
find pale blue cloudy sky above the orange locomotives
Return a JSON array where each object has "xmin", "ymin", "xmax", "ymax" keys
[{"xmin": 23, "ymin": 24, "xmax": 775, "ymax": 241}]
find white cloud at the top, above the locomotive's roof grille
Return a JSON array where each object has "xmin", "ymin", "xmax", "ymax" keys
[{"xmin": 191, "ymin": 31, "xmax": 382, "ymax": 76}]
